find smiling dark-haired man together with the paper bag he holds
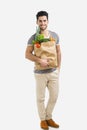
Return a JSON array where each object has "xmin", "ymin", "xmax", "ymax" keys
[{"xmin": 25, "ymin": 11, "xmax": 61, "ymax": 129}]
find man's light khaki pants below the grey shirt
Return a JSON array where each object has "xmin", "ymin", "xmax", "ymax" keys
[{"xmin": 35, "ymin": 69, "xmax": 59, "ymax": 120}]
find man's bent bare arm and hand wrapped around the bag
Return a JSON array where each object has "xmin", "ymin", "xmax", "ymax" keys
[{"xmin": 25, "ymin": 46, "xmax": 48, "ymax": 67}]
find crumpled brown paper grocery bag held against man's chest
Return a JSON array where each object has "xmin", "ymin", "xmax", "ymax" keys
[{"xmin": 34, "ymin": 41, "xmax": 57, "ymax": 70}]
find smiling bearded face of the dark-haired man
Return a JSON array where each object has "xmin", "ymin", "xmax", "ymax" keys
[{"xmin": 37, "ymin": 16, "xmax": 48, "ymax": 31}]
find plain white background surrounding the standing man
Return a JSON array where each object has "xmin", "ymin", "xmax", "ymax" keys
[{"xmin": 0, "ymin": 0, "xmax": 87, "ymax": 130}]
